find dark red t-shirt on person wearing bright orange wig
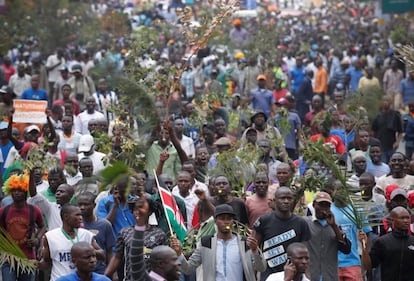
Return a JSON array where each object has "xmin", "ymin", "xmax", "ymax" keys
[{"xmin": 0, "ymin": 201, "xmax": 44, "ymax": 259}]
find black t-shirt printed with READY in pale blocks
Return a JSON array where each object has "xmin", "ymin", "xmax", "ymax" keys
[{"xmin": 253, "ymin": 212, "xmax": 311, "ymax": 280}]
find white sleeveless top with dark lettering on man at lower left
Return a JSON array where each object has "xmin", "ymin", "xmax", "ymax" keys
[{"xmin": 45, "ymin": 228, "xmax": 95, "ymax": 281}]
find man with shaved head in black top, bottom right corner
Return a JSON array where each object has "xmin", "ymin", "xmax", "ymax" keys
[{"xmin": 359, "ymin": 206, "xmax": 414, "ymax": 281}]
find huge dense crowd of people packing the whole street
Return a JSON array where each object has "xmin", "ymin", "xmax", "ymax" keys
[{"xmin": 0, "ymin": 1, "xmax": 414, "ymax": 281}]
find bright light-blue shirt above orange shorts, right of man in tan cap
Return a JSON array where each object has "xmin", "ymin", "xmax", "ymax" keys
[{"xmin": 331, "ymin": 204, "xmax": 371, "ymax": 267}]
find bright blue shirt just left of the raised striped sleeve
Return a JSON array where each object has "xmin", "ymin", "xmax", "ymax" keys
[{"xmin": 96, "ymin": 195, "xmax": 135, "ymax": 237}]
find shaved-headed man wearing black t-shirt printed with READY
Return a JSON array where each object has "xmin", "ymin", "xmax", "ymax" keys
[{"xmin": 253, "ymin": 186, "xmax": 311, "ymax": 281}]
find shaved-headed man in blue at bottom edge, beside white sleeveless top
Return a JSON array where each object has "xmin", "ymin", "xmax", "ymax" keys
[{"xmin": 57, "ymin": 242, "xmax": 111, "ymax": 281}]
